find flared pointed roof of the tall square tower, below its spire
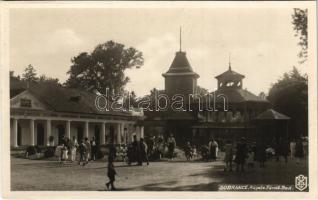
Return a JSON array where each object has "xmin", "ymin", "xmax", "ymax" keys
[{"xmin": 163, "ymin": 51, "xmax": 199, "ymax": 77}]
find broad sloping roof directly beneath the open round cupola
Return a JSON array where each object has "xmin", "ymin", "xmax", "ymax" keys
[{"xmin": 212, "ymin": 88, "xmax": 269, "ymax": 103}]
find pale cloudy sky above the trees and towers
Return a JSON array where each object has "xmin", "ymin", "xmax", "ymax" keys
[{"xmin": 10, "ymin": 8, "xmax": 306, "ymax": 96}]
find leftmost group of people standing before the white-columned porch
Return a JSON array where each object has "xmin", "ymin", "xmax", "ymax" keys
[{"xmin": 55, "ymin": 136, "xmax": 97, "ymax": 166}]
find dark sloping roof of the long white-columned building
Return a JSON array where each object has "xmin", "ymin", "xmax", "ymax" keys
[{"xmin": 10, "ymin": 79, "xmax": 131, "ymax": 116}]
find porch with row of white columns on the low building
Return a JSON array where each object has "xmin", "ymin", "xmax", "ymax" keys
[{"xmin": 10, "ymin": 116, "xmax": 144, "ymax": 147}]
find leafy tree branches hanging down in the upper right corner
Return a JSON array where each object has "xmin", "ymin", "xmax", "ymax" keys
[{"xmin": 292, "ymin": 8, "xmax": 308, "ymax": 63}]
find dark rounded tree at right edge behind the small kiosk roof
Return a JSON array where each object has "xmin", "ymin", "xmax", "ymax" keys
[{"xmin": 268, "ymin": 67, "xmax": 308, "ymax": 137}]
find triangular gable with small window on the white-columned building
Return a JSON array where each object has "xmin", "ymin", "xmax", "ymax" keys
[{"xmin": 10, "ymin": 90, "xmax": 48, "ymax": 110}]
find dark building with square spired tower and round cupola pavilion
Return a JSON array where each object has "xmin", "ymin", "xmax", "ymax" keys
[{"xmin": 143, "ymin": 48, "xmax": 286, "ymax": 144}]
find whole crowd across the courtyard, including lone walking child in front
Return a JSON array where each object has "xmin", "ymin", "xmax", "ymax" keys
[{"xmin": 19, "ymin": 134, "xmax": 308, "ymax": 190}]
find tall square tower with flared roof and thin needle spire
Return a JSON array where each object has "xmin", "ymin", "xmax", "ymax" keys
[{"xmin": 162, "ymin": 28, "xmax": 199, "ymax": 96}]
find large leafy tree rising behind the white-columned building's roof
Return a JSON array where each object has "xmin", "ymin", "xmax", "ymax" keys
[{"xmin": 66, "ymin": 41, "xmax": 144, "ymax": 94}]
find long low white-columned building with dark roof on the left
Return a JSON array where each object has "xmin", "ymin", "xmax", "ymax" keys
[{"xmin": 10, "ymin": 77, "xmax": 143, "ymax": 147}]
